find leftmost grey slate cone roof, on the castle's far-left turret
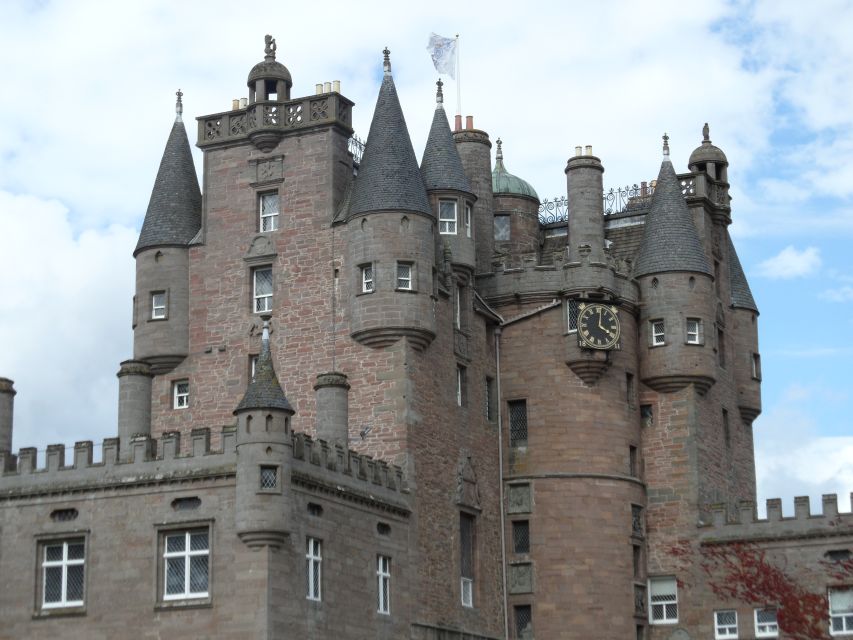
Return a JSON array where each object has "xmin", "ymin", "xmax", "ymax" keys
[{"xmin": 133, "ymin": 102, "xmax": 201, "ymax": 256}]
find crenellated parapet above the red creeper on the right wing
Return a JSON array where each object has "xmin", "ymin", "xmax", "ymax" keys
[{"xmin": 700, "ymin": 493, "xmax": 853, "ymax": 543}]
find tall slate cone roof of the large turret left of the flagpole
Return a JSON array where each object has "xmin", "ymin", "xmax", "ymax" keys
[{"xmin": 350, "ymin": 49, "xmax": 432, "ymax": 215}]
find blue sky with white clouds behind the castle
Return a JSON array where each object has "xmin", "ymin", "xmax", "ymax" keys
[{"xmin": 0, "ymin": 0, "xmax": 853, "ymax": 514}]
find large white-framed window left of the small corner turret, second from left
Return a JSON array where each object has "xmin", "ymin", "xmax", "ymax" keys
[{"xmin": 163, "ymin": 529, "xmax": 210, "ymax": 600}]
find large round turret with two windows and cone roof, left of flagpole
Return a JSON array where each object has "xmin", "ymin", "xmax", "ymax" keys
[{"xmin": 347, "ymin": 49, "xmax": 436, "ymax": 349}]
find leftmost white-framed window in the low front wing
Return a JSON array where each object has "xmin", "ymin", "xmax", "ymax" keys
[{"xmin": 40, "ymin": 538, "xmax": 86, "ymax": 609}]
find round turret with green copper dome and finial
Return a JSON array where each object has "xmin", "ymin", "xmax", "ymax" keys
[{"xmin": 492, "ymin": 139, "xmax": 540, "ymax": 264}]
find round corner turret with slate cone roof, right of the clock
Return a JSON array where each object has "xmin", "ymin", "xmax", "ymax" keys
[{"xmin": 634, "ymin": 135, "xmax": 716, "ymax": 393}]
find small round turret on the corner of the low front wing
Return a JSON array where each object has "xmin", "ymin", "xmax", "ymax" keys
[{"xmin": 234, "ymin": 315, "xmax": 294, "ymax": 548}]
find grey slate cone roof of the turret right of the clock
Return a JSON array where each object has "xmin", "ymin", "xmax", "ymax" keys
[{"xmin": 634, "ymin": 147, "xmax": 714, "ymax": 277}]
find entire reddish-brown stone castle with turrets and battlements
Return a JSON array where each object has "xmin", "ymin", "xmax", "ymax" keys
[{"xmin": 0, "ymin": 37, "xmax": 853, "ymax": 640}]
